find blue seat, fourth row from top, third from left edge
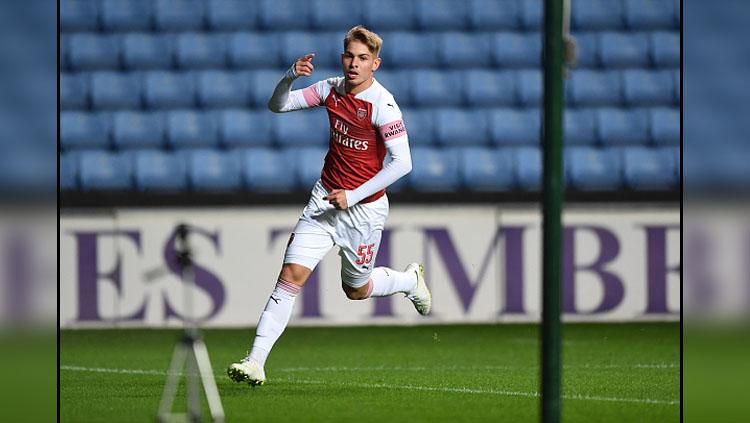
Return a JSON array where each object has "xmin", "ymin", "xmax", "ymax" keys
[{"xmin": 167, "ymin": 110, "xmax": 218, "ymax": 148}]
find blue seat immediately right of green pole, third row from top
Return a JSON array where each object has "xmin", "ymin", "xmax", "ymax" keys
[{"xmin": 567, "ymin": 69, "xmax": 622, "ymax": 106}]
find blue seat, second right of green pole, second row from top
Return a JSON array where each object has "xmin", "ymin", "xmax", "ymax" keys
[{"xmin": 599, "ymin": 32, "xmax": 650, "ymax": 68}]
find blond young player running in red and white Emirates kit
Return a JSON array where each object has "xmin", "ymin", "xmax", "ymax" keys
[{"xmin": 227, "ymin": 26, "xmax": 432, "ymax": 385}]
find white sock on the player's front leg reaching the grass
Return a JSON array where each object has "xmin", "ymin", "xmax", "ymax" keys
[{"xmin": 250, "ymin": 279, "xmax": 301, "ymax": 365}]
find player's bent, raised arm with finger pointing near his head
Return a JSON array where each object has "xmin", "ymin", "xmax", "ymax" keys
[{"xmin": 268, "ymin": 53, "xmax": 322, "ymax": 113}]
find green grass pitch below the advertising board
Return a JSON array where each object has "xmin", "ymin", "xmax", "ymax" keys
[{"xmin": 60, "ymin": 323, "xmax": 680, "ymax": 423}]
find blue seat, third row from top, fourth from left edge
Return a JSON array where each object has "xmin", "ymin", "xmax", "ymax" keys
[{"xmin": 197, "ymin": 70, "xmax": 250, "ymax": 107}]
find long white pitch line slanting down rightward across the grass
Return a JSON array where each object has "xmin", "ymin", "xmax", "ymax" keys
[{"xmin": 60, "ymin": 365, "xmax": 680, "ymax": 405}]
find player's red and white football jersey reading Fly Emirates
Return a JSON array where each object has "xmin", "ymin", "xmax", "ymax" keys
[{"xmin": 291, "ymin": 77, "xmax": 407, "ymax": 203}]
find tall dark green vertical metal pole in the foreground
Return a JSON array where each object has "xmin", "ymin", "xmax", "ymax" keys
[{"xmin": 541, "ymin": 0, "xmax": 564, "ymax": 423}]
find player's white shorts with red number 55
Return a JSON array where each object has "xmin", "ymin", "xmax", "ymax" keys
[{"xmin": 284, "ymin": 181, "xmax": 388, "ymax": 288}]
